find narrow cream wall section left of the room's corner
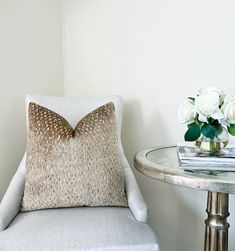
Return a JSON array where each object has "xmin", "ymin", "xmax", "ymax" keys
[{"xmin": 0, "ymin": 0, "xmax": 64, "ymax": 201}]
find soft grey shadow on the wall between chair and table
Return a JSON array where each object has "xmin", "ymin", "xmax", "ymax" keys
[{"xmin": 122, "ymin": 99, "xmax": 204, "ymax": 251}]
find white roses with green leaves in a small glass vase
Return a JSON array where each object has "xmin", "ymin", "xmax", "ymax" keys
[{"xmin": 178, "ymin": 87, "xmax": 235, "ymax": 152}]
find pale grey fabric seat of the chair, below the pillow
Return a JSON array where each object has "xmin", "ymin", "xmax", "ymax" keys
[{"xmin": 0, "ymin": 207, "xmax": 159, "ymax": 251}]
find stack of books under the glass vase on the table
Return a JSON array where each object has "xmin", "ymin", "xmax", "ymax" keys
[{"xmin": 177, "ymin": 146, "xmax": 235, "ymax": 171}]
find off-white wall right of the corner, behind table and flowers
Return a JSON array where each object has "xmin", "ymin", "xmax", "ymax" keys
[{"xmin": 63, "ymin": 0, "xmax": 235, "ymax": 251}]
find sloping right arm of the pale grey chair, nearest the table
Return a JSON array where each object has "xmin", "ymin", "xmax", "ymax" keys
[{"xmin": 124, "ymin": 164, "xmax": 148, "ymax": 223}]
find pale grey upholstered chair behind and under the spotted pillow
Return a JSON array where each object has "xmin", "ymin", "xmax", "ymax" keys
[{"xmin": 0, "ymin": 96, "xmax": 159, "ymax": 251}]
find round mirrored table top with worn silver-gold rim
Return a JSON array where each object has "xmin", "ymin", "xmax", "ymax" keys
[{"xmin": 135, "ymin": 146, "xmax": 235, "ymax": 193}]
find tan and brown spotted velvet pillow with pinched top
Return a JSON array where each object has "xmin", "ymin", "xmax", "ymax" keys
[{"xmin": 21, "ymin": 102, "xmax": 127, "ymax": 211}]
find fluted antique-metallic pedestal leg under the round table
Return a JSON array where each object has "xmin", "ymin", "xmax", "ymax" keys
[{"xmin": 204, "ymin": 192, "xmax": 229, "ymax": 251}]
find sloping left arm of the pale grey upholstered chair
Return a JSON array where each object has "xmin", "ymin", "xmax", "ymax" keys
[{"xmin": 0, "ymin": 154, "xmax": 26, "ymax": 232}]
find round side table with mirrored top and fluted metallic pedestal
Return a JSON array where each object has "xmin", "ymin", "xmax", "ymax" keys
[{"xmin": 134, "ymin": 146, "xmax": 235, "ymax": 251}]
